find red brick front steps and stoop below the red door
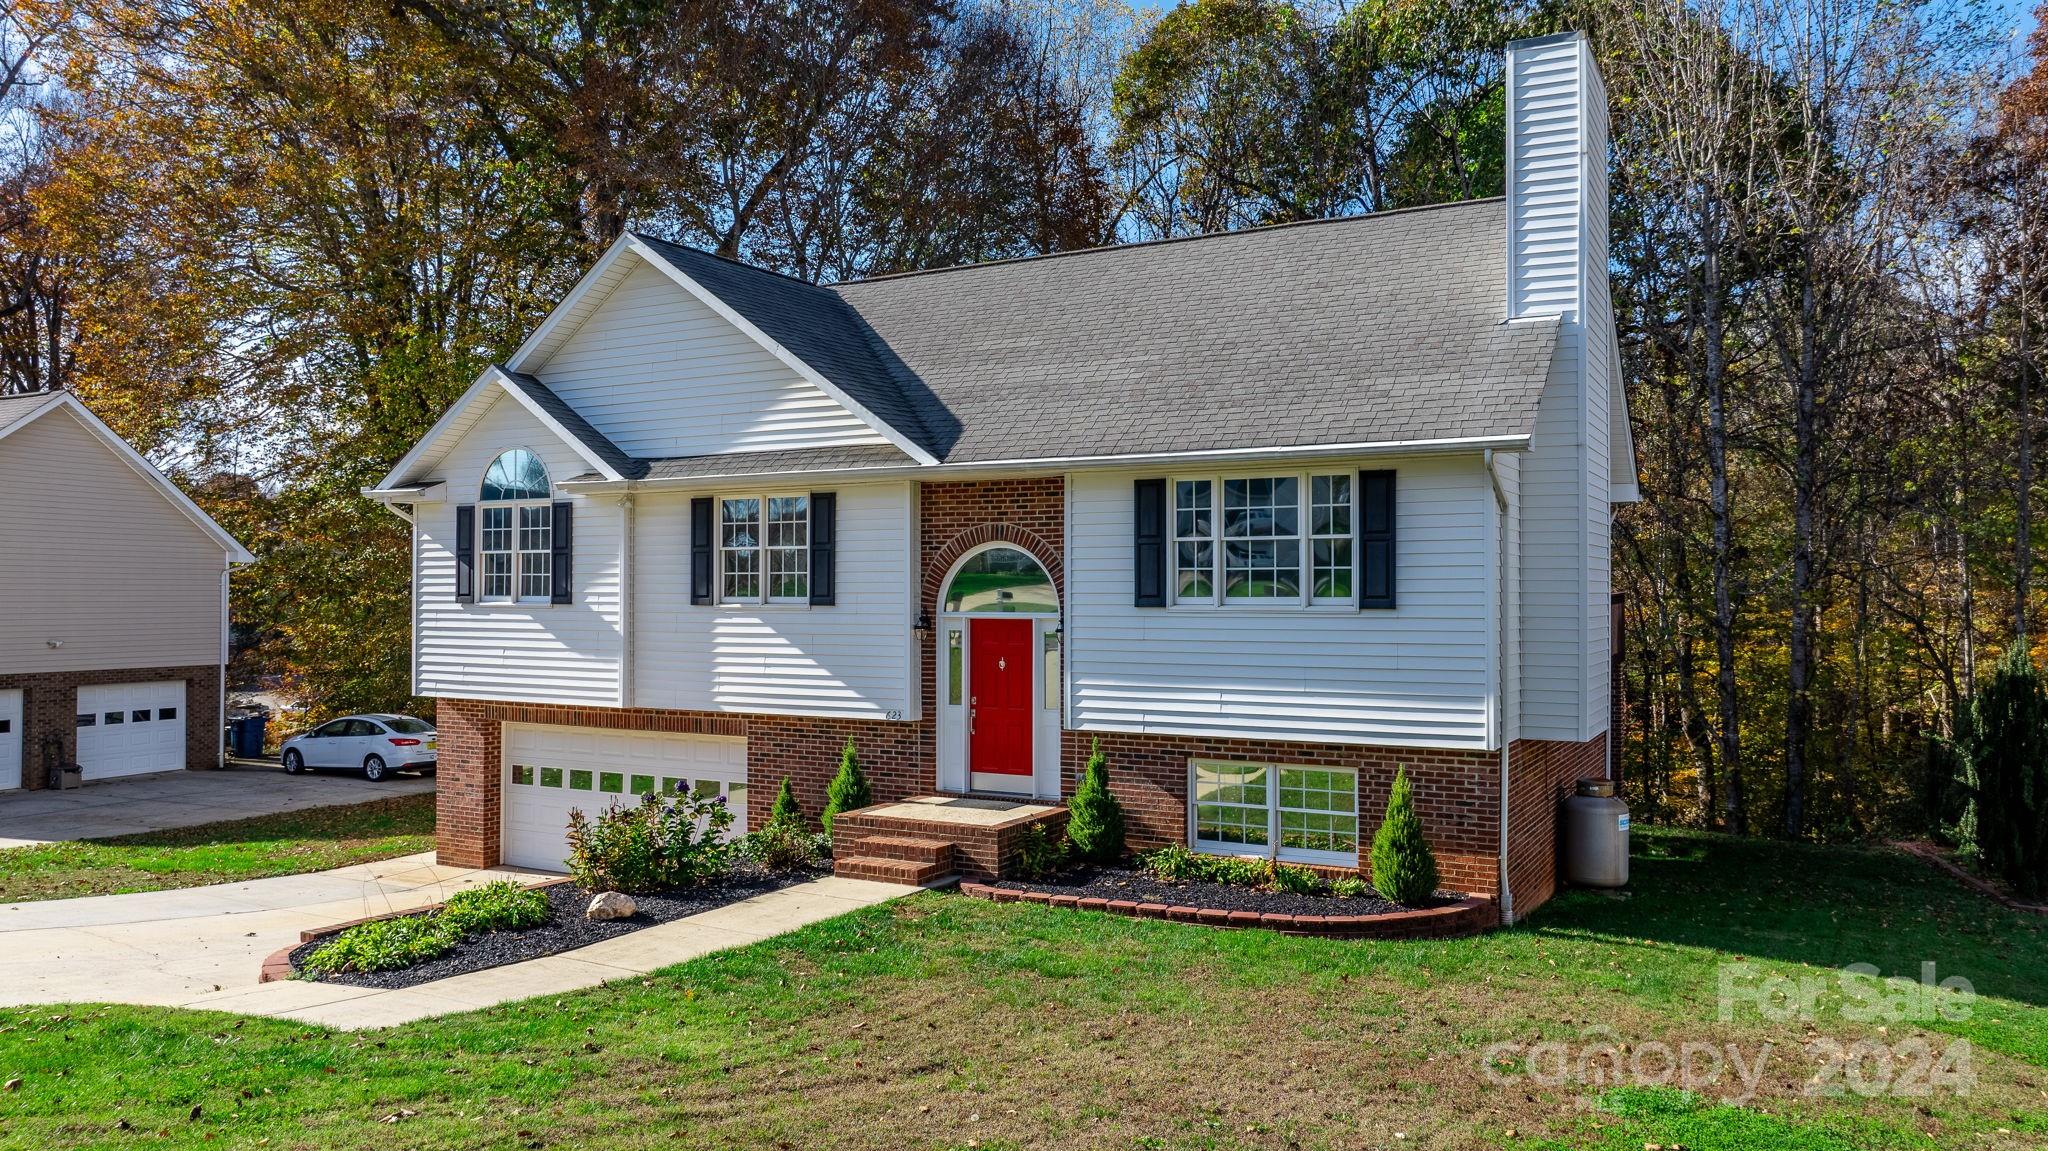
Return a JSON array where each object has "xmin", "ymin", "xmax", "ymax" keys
[{"xmin": 831, "ymin": 795, "xmax": 1067, "ymax": 887}]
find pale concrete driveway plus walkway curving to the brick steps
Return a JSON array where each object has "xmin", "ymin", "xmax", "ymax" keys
[{"xmin": 0, "ymin": 854, "xmax": 915, "ymax": 1028}]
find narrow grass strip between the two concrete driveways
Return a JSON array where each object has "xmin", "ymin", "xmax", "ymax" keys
[{"xmin": 0, "ymin": 795, "xmax": 434, "ymax": 903}]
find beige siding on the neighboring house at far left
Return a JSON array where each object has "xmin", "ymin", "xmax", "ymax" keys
[{"xmin": 0, "ymin": 412, "xmax": 227, "ymax": 671}]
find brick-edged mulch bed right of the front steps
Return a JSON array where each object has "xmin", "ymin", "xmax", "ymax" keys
[{"xmin": 961, "ymin": 866, "xmax": 1499, "ymax": 940}]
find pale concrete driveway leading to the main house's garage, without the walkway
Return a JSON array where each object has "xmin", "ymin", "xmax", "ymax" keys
[{"xmin": 0, "ymin": 851, "xmax": 537, "ymax": 1010}]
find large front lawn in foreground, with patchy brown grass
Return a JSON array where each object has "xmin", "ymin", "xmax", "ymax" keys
[{"xmin": 0, "ymin": 832, "xmax": 2048, "ymax": 1151}]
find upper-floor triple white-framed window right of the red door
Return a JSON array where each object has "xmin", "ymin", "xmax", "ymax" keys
[{"xmin": 1171, "ymin": 471, "xmax": 1358, "ymax": 606}]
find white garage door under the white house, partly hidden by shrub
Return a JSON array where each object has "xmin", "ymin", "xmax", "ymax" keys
[{"xmin": 500, "ymin": 723, "xmax": 748, "ymax": 870}]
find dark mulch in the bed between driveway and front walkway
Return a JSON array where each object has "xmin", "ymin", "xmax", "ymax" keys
[{"xmin": 291, "ymin": 864, "xmax": 825, "ymax": 989}]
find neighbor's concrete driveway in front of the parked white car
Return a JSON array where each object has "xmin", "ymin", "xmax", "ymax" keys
[{"xmin": 0, "ymin": 764, "xmax": 434, "ymax": 848}]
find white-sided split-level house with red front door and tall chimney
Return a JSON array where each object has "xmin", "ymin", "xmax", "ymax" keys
[{"xmin": 371, "ymin": 35, "xmax": 1636, "ymax": 913}]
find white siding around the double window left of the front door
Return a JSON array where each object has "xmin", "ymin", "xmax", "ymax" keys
[{"xmin": 633, "ymin": 483, "xmax": 918, "ymax": 719}]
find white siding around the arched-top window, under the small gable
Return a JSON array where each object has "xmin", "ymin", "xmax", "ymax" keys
[{"xmin": 414, "ymin": 393, "xmax": 623, "ymax": 707}]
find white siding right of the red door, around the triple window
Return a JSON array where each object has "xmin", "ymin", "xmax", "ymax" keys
[{"xmin": 1067, "ymin": 455, "xmax": 1495, "ymax": 748}]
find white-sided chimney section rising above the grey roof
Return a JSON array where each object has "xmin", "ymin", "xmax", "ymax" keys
[{"xmin": 1507, "ymin": 33, "xmax": 1608, "ymax": 322}]
